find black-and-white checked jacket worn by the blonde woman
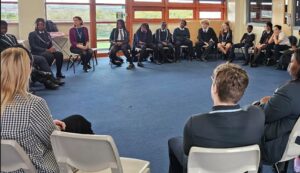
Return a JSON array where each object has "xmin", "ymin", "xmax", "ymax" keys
[{"xmin": 1, "ymin": 94, "xmax": 59, "ymax": 173}]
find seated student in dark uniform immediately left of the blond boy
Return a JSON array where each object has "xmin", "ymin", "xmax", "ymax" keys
[{"xmin": 173, "ymin": 20, "xmax": 193, "ymax": 61}]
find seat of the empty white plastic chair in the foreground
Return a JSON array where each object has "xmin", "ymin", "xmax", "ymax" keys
[{"xmin": 76, "ymin": 157, "xmax": 150, "ymax": 173}]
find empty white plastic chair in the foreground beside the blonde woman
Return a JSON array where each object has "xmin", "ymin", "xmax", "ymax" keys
[{"xmin": 50, "ymin": 131, "xmax": 150, "ymax": 173}]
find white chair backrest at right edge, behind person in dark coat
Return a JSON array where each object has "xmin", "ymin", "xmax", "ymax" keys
[{"xmin": 280, "ymin": 118, "xmax": 300, "ymax": 162}]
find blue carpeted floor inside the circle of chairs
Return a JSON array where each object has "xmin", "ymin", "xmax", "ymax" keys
[{"xmin": 36, "ymin": 59, "xmax": 289, "ymax": 173}]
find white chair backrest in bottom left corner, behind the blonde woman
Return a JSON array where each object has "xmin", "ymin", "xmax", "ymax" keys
[{"xmin": 1, "ymin": 140, "xmax": 37, "ymax": 173}]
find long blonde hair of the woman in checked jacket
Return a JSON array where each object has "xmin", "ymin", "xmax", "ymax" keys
[{"xmin": 1, "ymin": 47, "xmax": 31, "ymax": 115}]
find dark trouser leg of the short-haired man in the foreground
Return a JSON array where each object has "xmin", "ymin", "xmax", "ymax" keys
[{"xmin": 168, "ymin": 137, "xmax": 188, "ymax": 173}]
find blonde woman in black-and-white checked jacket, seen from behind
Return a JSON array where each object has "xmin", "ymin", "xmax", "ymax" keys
[{"xmin": 1, "ymin": 47, "xmax": 93, "ymax": 173}]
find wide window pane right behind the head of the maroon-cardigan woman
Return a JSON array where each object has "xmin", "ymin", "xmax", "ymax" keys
[{"xmin": 47, "ymin": 4, "xmax": 90, "ymax": 22}]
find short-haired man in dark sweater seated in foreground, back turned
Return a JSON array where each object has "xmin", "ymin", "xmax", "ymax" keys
[{"xmin": 168, "ymin": 63, "xmax": 265, "ymax": 173}]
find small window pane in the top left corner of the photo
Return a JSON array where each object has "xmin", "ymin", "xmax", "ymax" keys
[{"xmin": 1, "ymin": 0, "xmax": 19, "ymax": 22}]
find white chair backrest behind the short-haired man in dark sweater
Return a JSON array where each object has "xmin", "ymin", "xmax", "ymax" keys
[{"xmin": 188, "ymin": 145, "xmax": 260, "ymax": 173}]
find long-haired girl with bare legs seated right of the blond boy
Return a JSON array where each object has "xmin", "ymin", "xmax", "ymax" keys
[{"xmin": 218, "ymin": 22, "xmax": 232, "ymax": 59}]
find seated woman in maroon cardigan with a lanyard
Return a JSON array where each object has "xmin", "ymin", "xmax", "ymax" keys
[{"xmin": 69, "ymin": 16, "xmax": 93, "ymax": 72}]
